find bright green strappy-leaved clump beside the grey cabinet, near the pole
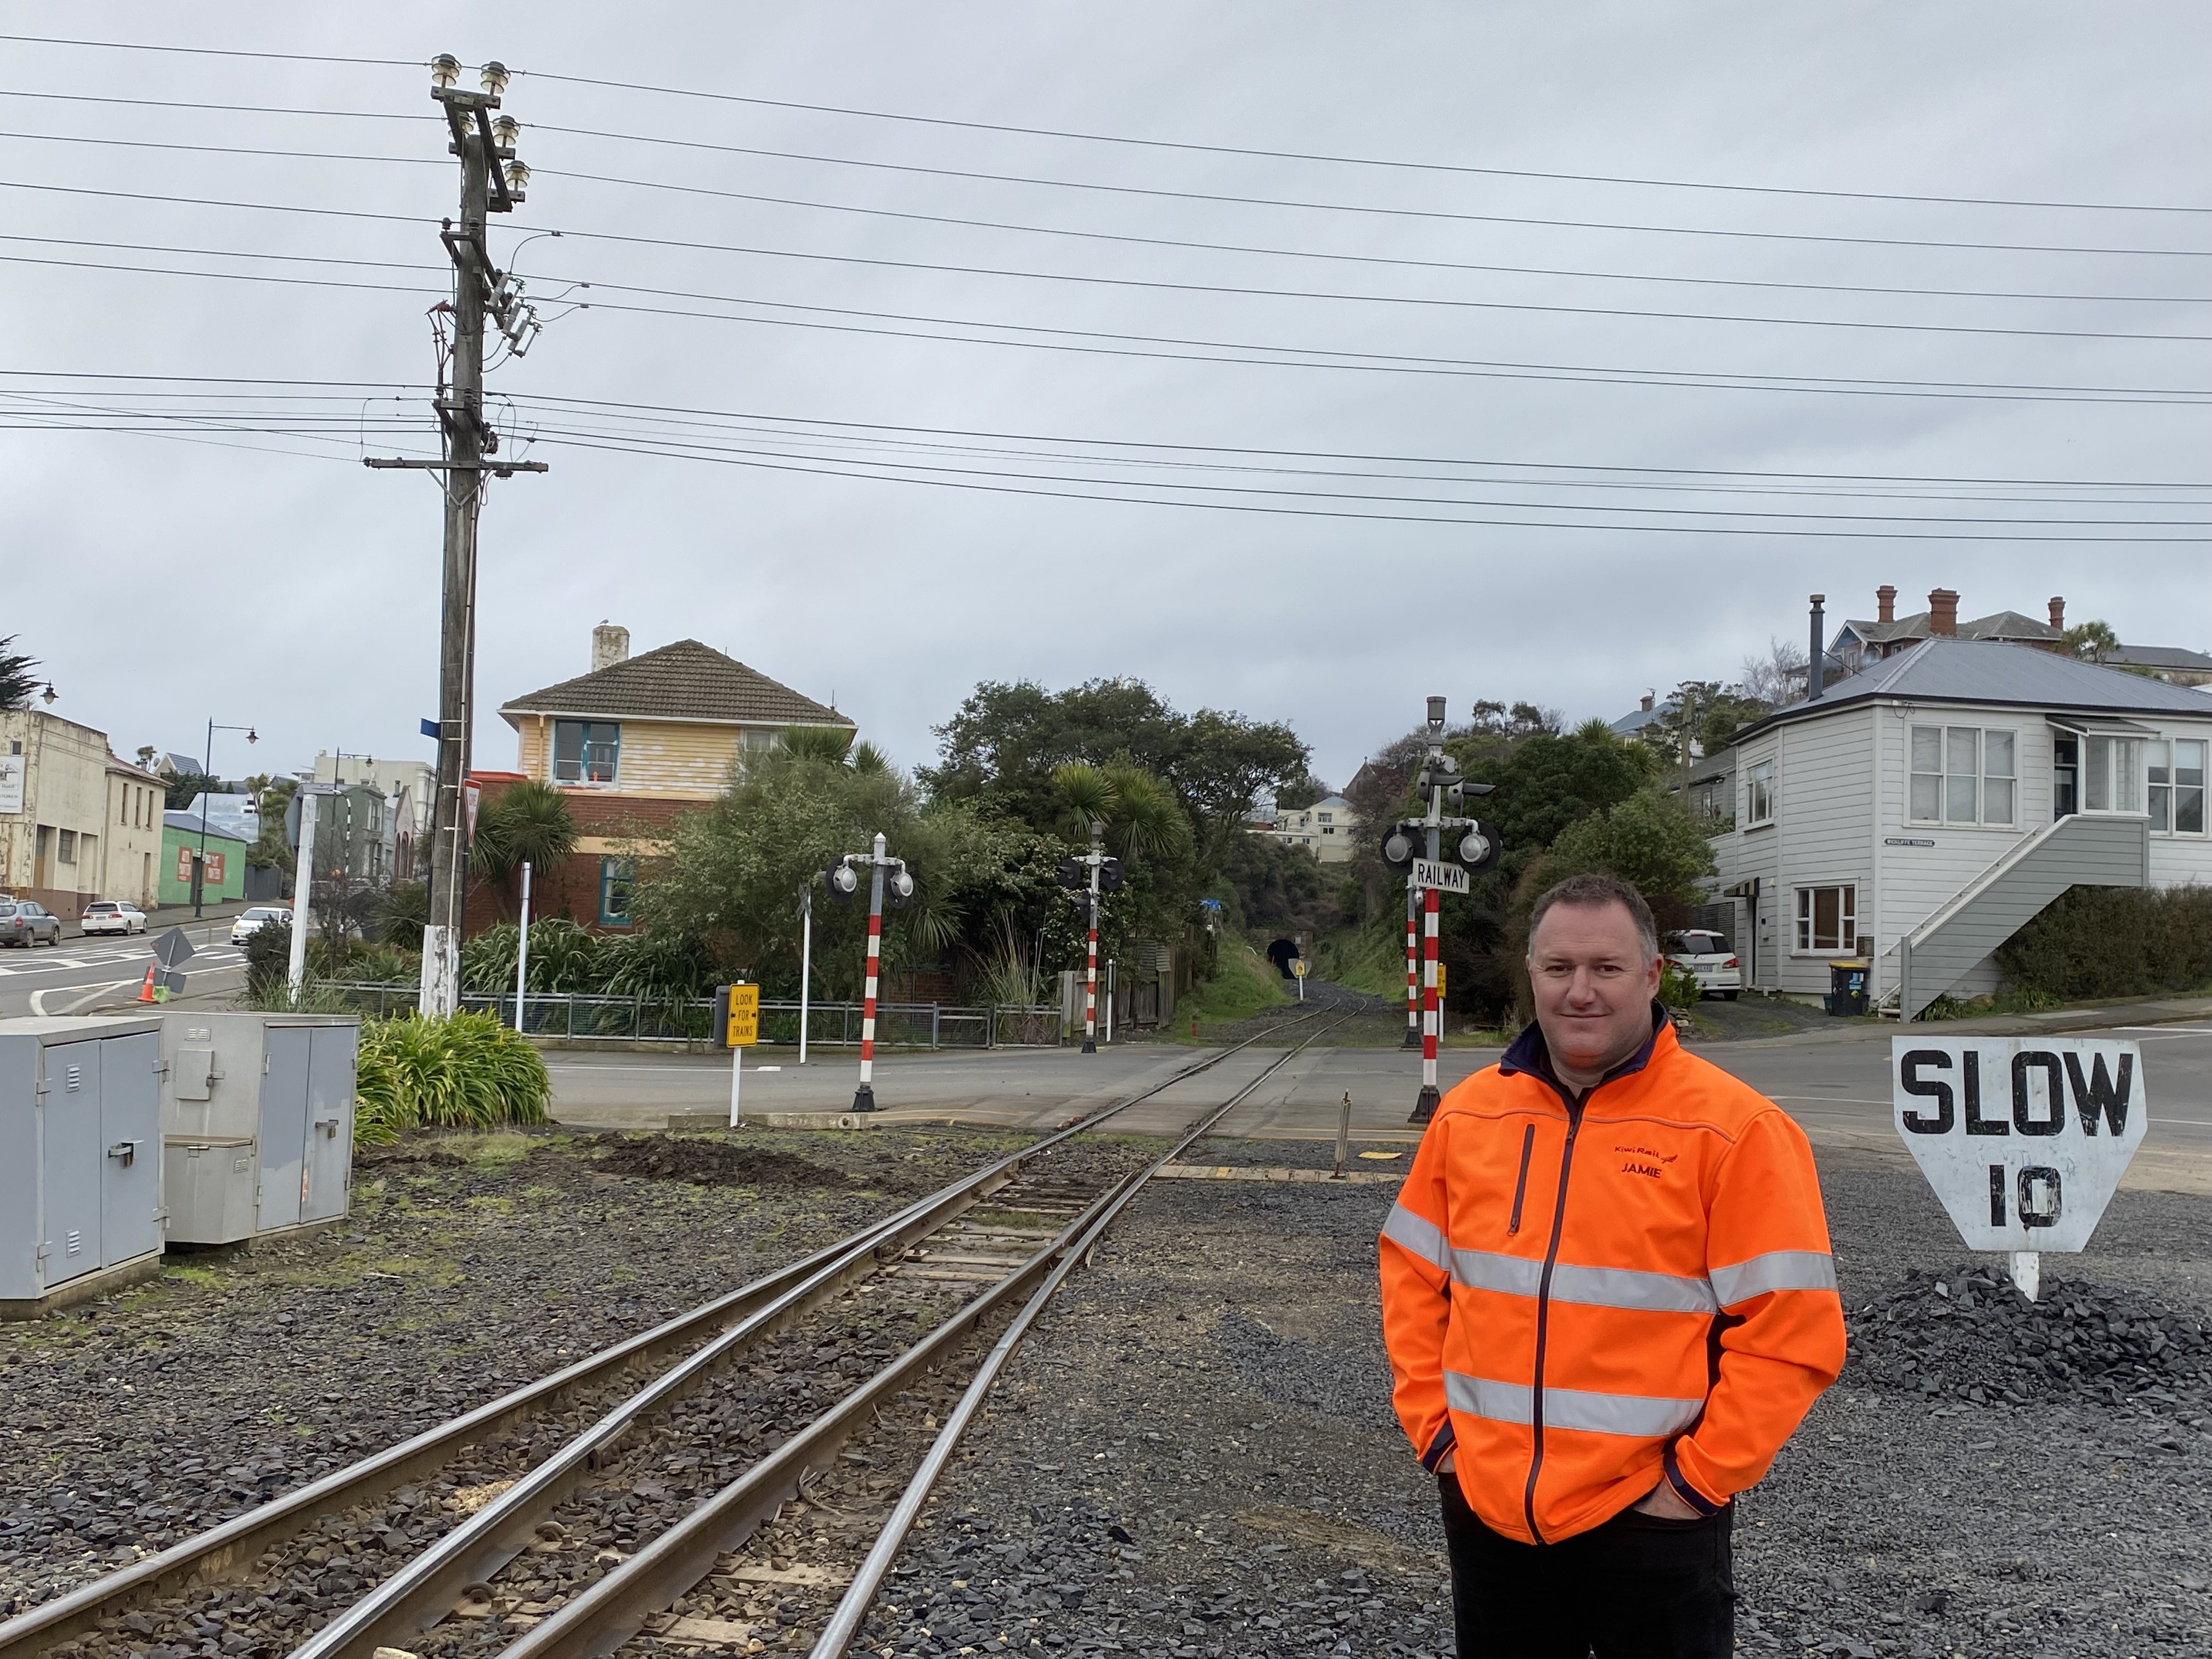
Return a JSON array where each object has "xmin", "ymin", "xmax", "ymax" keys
[{"xmin": 354, "ymin": 1013, "xmax": 551, "ymax": 1146}]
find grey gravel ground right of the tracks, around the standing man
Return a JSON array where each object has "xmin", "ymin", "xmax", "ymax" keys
[{"xmin": 870, "ymin": 1144, "xmax": 2212, "ymax": 1659}]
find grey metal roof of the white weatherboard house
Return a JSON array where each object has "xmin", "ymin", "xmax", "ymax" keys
[{"xmin": 1736, "ymin": 639, "xmax": 2205, "ymax": 743}]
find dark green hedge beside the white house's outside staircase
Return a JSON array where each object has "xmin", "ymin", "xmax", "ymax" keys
[{"xmin": 1999, "ymin": 883, "xmax": 2212, "ymax": 1018}]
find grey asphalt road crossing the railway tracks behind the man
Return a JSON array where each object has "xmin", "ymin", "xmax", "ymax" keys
[{"xmin": 546, "ymin": 1022, "xmax": 2212, "ymax": 1192}]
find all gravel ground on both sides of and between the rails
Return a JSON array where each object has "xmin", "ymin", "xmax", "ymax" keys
[{"xmin": 0, "ymin": 1128, "xmax": 2212, "ymax": 1659}]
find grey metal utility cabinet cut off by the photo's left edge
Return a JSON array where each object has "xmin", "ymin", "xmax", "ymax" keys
[{"xmin": 0, "ymin": 1015, "xmax": 161, "ymax": 1316}]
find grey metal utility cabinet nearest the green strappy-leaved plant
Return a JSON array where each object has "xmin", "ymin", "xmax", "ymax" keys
[{"xmin": 161, "ymin": 1009, "xmax": 360, "ymax": 1245}]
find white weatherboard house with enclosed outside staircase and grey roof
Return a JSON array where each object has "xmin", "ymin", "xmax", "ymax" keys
[{"xmin": 1708, "ymin": 637, "xmax": 2212, "ymax": 1018}]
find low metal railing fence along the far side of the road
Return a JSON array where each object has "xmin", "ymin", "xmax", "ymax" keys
[{"xmin": 323, "ymin": 980, "xmax": 1066, "ymax": 1048}]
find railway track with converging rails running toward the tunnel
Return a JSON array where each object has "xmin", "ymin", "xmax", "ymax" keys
[{"xmin": 0, "ymin": 1009, "xmax": 1345, "ymax": 1659}]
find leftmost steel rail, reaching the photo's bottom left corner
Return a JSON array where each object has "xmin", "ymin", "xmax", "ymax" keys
[{"xmin": 0, "ymin": 1011, "xmax": 1321, "ymax": 1659}]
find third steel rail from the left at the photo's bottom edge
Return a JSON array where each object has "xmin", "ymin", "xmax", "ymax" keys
[{"xmin": 500, "ymin": 1011, "xmax": 1352, "ymax": 1659}]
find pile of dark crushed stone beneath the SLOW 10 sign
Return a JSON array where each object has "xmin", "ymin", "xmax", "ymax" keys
[{"xmin": 1845, "ymin": 1267, "xmax": 2212, "ymax": 1404}]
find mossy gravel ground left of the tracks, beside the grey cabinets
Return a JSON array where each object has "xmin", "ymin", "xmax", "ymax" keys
[{"xmin": 0, "ymin": 1130, "xmax": 1053, "ymax": 1612}]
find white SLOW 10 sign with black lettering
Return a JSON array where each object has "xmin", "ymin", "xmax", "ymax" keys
[{"xmin": 1889, "ymin": 1037, "xmax": 2150, "ymax": 1256}]
